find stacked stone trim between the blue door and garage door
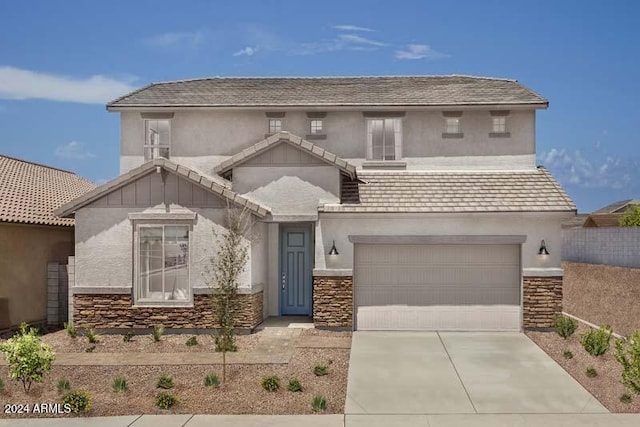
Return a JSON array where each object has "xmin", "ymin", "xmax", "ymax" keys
[{"xmin": 313, "ymin": 276, "xmax": 353, "ymax": 329}]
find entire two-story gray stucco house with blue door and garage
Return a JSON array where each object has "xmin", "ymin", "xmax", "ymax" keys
[{"xmin": 57, "ymin": 75, "xmax": 576, "ymax": 331}]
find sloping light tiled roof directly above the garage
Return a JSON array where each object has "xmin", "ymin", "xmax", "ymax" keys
[{"xmin": 321, "ymin": 167, "xmax": 576, "ymax": 212}]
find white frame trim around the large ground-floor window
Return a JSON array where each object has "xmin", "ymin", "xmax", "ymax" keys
[{"xmin": 133, "ymin": 220, "xmax": 193, "ymax": 307}]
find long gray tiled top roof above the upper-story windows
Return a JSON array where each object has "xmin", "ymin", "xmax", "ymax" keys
[{"xmin": 107, "ymin": 75, "xmax": 548, "ymax": 109}]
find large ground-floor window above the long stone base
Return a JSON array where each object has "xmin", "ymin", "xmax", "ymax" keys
[{"xmin": 137, "ymin": 225, "xmax": 191, "ymax": 303}]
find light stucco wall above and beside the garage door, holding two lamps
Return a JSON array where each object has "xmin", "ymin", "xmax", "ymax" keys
[{"xmin": 315, "ymin": 213, "xmax": 570, "ymax": 269}]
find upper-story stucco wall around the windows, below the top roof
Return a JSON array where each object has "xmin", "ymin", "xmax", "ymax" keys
[{"xmin": 120, "ymin": 109, "xmax": 535, "ymax": 173}]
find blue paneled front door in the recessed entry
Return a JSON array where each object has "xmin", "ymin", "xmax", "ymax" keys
[{"xmin": 280, "ymin": 225, "xmax": 311, "ymax": 316}]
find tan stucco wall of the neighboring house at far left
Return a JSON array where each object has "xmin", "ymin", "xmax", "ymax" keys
[{"xmin": 0, "ymin": 223, "xmax": 74, "ymax": 326}]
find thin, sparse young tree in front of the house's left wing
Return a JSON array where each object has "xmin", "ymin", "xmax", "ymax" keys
[{"xmin": 208, "ymin": 206, "xmax": 253, "ymax": 383}]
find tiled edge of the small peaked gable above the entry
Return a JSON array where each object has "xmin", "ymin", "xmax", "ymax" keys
[{"xmin": 214, "ymin": 132, "xmax": 356, "ymax": 178}]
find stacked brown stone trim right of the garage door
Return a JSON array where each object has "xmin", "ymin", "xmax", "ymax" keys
[{"xmin": 522, "ymin": 276, "xmax": 562, "ymax": 329}]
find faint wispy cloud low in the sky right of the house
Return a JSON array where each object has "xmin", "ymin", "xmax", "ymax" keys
[{"xmin": 538, "ymin": 148, "xmax": 640, "ymax": 190}]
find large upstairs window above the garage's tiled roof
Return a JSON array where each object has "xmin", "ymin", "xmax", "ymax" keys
[{"xmin": 367, "ymin": 119, "xmax": 402, "ymax": 160}]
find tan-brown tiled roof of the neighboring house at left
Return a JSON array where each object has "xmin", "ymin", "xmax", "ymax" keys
[{"xmin": 0, "ymin": 155, "xmax": 95, "ymax": 226}]
